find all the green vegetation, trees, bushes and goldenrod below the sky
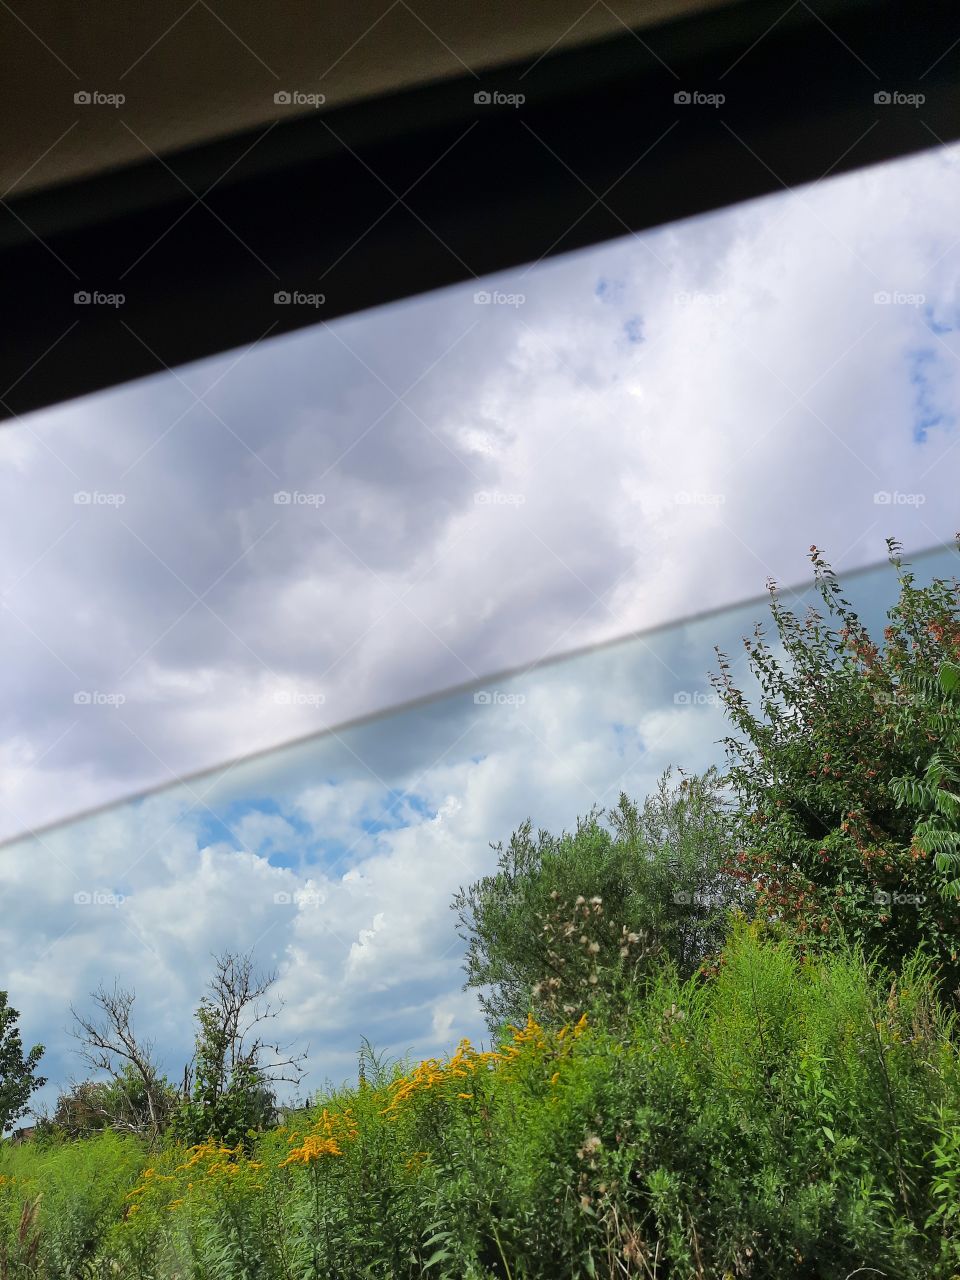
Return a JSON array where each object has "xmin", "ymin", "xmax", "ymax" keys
[{"xmin": 0, "ymin": 543, "xmax": 960, "ymax": 1280}]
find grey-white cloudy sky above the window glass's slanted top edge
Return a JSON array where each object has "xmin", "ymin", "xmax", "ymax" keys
[{"xmin": 0, "ymin": 140, "xmax": 960, "ymax": 839}]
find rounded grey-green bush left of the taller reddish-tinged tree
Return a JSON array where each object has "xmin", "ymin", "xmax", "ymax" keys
[{"xmin": 452, "ymin": 769, "xmax": 745, "ymax": 1028}]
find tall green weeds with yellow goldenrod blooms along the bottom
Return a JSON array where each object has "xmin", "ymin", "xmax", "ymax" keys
[{"xmin": 0, "ymin": 925, "xmax": 960, "ymax": 1280}]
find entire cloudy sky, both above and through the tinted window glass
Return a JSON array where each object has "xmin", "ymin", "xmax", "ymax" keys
[{"xmin": 0, "ymin": 135, "xmax": 960, "ymax": 1121}]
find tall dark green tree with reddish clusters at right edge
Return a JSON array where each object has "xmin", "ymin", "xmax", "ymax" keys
[{"xmin": 713, "ymin": 540, "xmax": 960, "ymax": 989}]
